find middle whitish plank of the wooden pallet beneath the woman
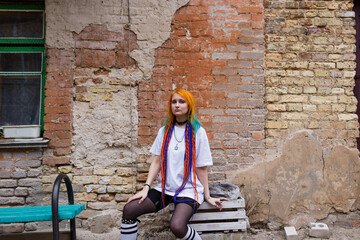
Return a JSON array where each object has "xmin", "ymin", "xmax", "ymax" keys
[{"xmin": 191, "ymin": 209, "xmax": 246, "ymax": 222}]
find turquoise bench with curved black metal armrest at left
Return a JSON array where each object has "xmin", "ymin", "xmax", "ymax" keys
[{"xmin": 0, "ymin": 174, "xmax": 85, "ymax": 240}]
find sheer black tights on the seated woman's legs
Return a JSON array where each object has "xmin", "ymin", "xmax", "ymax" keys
[{"xmin": 123, "ymin": 197, "xmax": 193, "ymax": 238}]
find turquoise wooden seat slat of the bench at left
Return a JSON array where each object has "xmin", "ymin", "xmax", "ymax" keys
[{"xmin": 0, "ymin": 204, "xmax": 85, "ymax": 223}]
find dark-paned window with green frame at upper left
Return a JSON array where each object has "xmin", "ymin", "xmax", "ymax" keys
[{"xmin": 0, "ymin": 1, "xmax": 45, "ymax": 127}]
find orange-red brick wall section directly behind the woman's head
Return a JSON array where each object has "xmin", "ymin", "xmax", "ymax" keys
[{"xmin": 138, "ymin": 1, "xmax": 265, "ymax": 181}]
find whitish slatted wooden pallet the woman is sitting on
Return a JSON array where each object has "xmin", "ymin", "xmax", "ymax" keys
[{"xmin": 170, "ymin": 198, "xmax": 250, "ymax": 233}]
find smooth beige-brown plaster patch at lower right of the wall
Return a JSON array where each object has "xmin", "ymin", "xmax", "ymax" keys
[{"xmin": 235, "ymin": 131, "xmax": 360, "ymax": 227}]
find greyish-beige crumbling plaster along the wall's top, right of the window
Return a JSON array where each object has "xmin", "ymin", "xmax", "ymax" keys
[{"xmin": 45, "ymin": 0, "xmax": 189, "ymax": 79}]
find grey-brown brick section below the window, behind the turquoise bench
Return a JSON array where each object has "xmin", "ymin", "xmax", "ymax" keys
[{"xmin": 0, "ymin": 149, "xmax": 44, "ymax": 233}]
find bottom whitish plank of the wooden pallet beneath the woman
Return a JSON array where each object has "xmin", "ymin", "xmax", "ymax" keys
[{"xmin": 190, "ymin": 220, "xmax": 246, "ymax": 232}]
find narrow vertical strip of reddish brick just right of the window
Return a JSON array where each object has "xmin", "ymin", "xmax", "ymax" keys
[{"xmin": 43, "ymin": 48, "xmax": 75, "ymax": 165}]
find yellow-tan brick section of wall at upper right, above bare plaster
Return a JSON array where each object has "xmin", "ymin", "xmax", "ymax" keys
[{"xmin": 264, "ymin": 1, "xmax": 358, "ymax": 149}]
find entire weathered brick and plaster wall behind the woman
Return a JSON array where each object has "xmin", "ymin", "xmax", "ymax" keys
[{"xmin": 0, "ymin": 0, "xmax": 360, "ymax": 240}]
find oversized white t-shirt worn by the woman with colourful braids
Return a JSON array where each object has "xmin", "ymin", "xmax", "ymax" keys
[{"xmin": 150, "ymin": 126, "xmax": 213, "ymax": 204}]
